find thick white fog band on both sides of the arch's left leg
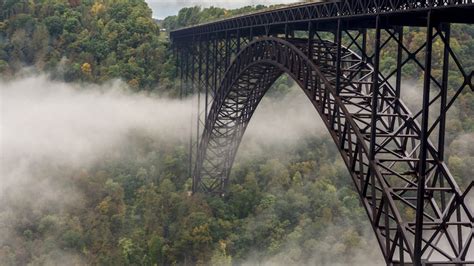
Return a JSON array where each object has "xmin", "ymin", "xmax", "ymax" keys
[{"xmin": 0, "ymin": 75, "xmax": 325, "ymax": 210}]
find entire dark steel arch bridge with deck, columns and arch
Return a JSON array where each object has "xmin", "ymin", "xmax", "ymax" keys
[{"xmin": 170, "ymin": 0, "xmax": 474, "ymax": 265}]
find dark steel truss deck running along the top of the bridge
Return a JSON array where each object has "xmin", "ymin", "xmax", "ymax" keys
[{"xmin": 170, "ymin": 0, "xmax": 474, "ymax": 40}]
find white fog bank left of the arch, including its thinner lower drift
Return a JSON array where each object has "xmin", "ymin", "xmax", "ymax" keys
[{"xmin": 0, "ymin": 75, "xmax": 193, "ymax": 258}]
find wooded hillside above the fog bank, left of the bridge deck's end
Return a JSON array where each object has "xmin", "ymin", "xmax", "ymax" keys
[{"xmin": 0, "ymin": 0, "xmax": 172, "ymax": 90}]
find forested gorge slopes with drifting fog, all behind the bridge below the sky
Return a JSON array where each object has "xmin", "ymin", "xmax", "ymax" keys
[{"xmin": 0, "ymin": 0, "xmax": 474, "ymax": 265}]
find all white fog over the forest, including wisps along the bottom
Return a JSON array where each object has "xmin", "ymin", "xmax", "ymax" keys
[{"xmin": 0, "ymin": 75, "xmax": 466, "ymax": 265}]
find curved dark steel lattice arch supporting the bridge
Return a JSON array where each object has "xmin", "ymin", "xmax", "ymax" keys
[{"xmin": 193, "ymin": 37, "xmax": 474, "ymax": 264}]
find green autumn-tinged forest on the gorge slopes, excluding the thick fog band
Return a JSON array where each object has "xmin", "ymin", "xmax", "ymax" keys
[{"xmin": 0, "ymin": 0, "xmax": 474, "ymax": 265}]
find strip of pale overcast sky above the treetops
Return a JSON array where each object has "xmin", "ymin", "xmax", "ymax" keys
[{"xmin": 146, "ymin": 0, "xmax": 299, "ymax": 19}]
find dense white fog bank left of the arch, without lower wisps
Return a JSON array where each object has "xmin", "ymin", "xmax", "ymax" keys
[{"xmin": 0, "ymin": 76, "xmax": 192, "ymax": 191}]
